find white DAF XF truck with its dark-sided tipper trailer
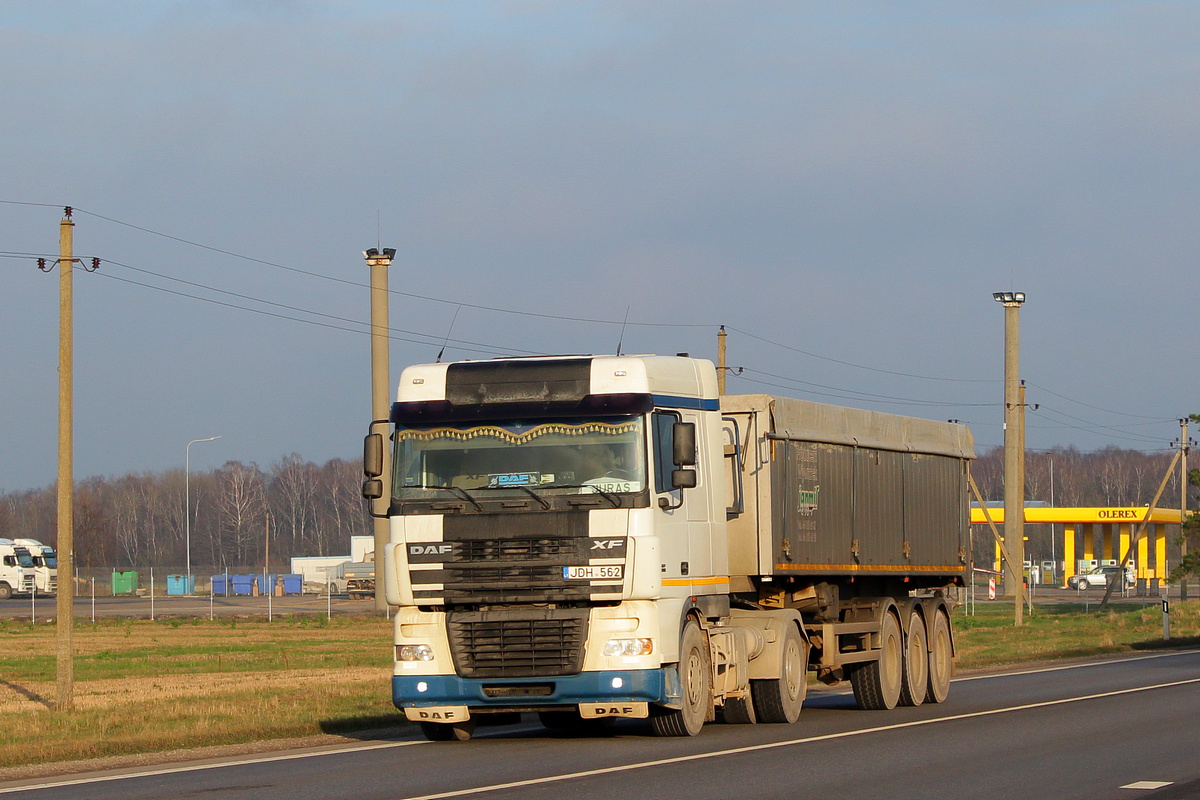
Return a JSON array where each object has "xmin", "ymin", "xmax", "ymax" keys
[{"xmin": 364, "ymin": 356, "xmax": 974, "ymax": 740}]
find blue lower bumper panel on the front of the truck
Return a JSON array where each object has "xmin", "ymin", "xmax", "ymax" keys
[{"xmin": 391, "ymin": 669, "xmax": 679, "ymax": 709}]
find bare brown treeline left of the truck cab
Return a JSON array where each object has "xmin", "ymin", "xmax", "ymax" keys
[{"xmin": 0, "ymin": 453, "xmax": 372, "ymax": 575}]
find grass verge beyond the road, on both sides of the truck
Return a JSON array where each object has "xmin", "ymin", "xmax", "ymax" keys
[{"xmin": 0, "ymin": 601, "xmax": 1200, "ymax": 778}]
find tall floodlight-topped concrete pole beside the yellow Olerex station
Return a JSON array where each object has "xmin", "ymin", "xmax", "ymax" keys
[{"xmin": 991, "ymin": 291, "xmax": 1025, "ymax": 625}]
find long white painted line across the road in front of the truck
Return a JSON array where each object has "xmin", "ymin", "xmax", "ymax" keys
[{"xmin": 403, "ymin": 678, "xmax": 1200, "ymax": 800}]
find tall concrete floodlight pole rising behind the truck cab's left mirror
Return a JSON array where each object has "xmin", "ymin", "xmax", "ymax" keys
[{"xmin": 362, "ymin": 247, "xmax": 396, "ymax": 610}]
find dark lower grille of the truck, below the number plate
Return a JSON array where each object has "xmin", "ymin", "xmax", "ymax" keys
[{"xmin": 446, "ymin": 608, "xmax": 588, "ymax": 678}]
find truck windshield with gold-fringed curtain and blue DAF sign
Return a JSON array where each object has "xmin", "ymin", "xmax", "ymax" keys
[{"xmin": 395, "ymin": 416, "xmax": 646, "ymax": 499}]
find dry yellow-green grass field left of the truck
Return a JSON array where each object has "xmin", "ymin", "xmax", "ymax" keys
[{"xmin": 0, "ymin": 618, "xmax": 401, "ymax": 768}]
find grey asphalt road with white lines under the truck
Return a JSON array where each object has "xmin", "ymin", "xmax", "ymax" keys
[{"xmin": 0, "ymin": 650, "xmax": 1200, "ymax": 800}]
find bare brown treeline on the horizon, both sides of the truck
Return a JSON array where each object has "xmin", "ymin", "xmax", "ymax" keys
[{"xmin": 0, "ymin": 447, "xmax": 1200, "ymax": 575}]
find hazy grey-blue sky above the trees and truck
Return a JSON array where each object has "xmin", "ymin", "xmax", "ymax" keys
[{"xmin": 0, "ymin": 0, "xmax": 1200, "ymax": 492}]
